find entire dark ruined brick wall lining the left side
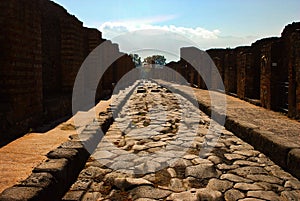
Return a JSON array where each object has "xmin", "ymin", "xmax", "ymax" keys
[{"xmin": 0, "ymin": 0, "xmax": 134, "ymax": 145}]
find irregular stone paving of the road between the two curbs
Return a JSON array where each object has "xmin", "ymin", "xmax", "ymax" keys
[{"xmin": 63, "ymin": 82, "xmax": 300, "ymax": 201}]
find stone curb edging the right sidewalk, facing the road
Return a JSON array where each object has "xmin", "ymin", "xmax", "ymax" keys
[{"xmin": 154, "ymin": 80, "xmax": 300, "ymax": 179}]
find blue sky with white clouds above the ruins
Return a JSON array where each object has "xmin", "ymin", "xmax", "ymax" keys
[{"xmin": 54, "ymin": 0, "xmax": 300, "ymax": 61}]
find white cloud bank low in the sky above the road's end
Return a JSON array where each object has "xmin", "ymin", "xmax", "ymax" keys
[{"xmin": 99, "ymin": 15, "xmax": 255, "ymax": 61}]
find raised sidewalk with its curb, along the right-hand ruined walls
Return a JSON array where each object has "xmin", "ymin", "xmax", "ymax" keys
[{"xmin": 156, "ymin": 80, "xmax": 300, "ymax": 179}]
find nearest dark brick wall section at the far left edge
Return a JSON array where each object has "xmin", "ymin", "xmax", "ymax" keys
[{"xmin": 0, "ymin": 0, "xmax": 43, "ymax": 143}]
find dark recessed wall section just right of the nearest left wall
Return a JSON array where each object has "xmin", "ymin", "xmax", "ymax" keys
[{"xmin": 41, "ymin": 0, "xmax": 71, "ymax": 121}]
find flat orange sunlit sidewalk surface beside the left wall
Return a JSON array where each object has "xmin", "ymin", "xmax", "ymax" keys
[{"xmin": 0, "ymin": 100, "xmax": 110, "ymax": 193}]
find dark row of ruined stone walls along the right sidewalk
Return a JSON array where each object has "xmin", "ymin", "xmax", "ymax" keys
[{"xmin": 167, "ymin": 22, "xmax": 300, "ymax": 118}]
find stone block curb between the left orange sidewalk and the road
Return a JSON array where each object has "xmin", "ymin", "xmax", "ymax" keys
[{"xmin": 0, "ymin": 82, "xmax": 139, "ymax": 201}]
